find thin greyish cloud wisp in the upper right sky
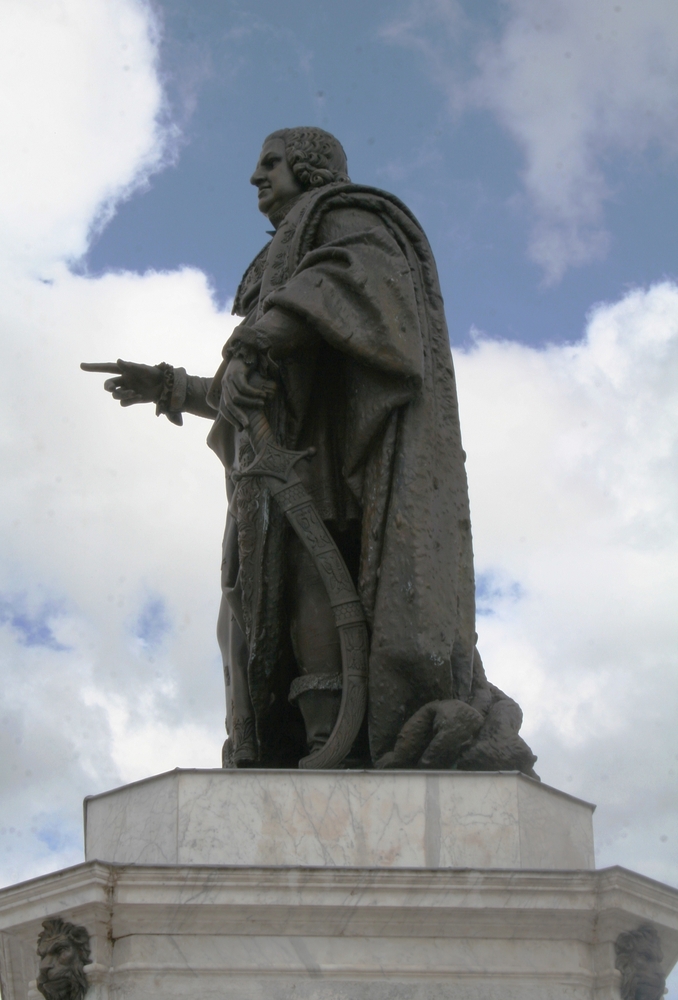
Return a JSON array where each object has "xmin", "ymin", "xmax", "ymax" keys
[{"xmin": 385, "ymin": 0, "xmax": 678, "ymax": 283}]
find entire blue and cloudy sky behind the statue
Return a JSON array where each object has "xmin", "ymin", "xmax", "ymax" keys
[{"xmin": 0, "ymin": 0, "xmax": 678, "ymax": 984}]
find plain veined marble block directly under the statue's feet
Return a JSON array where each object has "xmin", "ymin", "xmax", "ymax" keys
[{"xmin": 85, "ymin": 770, "xmax": 594, "ymax": 869}]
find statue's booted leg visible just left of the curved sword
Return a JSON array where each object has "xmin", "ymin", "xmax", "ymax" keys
[{"xmin": 287, "ymin": 535, "xmax": 341, "ymax": 751}]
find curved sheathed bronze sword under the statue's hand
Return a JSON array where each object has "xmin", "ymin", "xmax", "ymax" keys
[{"xmin": 233, "ymin": 402, "xmax": 369, "ymax": 770}]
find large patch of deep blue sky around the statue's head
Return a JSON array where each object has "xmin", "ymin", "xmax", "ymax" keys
[{"xmin": 85, "ymin": 0, "xmax": 678, "ymax": 350}]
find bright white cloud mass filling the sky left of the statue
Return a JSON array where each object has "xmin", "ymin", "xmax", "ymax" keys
[{"xmin": 0, "ymin": 0, "xmax": 238, "ymax": 883}]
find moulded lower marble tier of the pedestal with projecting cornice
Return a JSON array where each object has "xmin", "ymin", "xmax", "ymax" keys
[{"xmin": 0, "ymin": 862, "xmax": 678, "ymax": 1000}]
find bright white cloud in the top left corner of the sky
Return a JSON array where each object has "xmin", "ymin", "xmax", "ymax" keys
[{"xmin": 0, "ymin": 0, "xmax": 168, "ymax": 274}]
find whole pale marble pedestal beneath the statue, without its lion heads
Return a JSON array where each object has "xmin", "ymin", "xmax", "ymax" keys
[{"xmin": 0, "ymin": 771, "xmax": 678, "ymax": 1000}]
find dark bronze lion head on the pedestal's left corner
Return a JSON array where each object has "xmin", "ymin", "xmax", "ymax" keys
[{"xmin": 36, "ymin": 917, "xmax": 90, "ymax": 1000}]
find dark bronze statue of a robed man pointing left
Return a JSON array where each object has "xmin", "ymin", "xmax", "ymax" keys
[{"xmin": 83, "ymin": 128, "xmax": 536, "ymax": 776}]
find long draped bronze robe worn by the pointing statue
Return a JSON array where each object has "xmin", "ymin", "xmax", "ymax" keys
[{"xmin": 208, "ymin": 183, "xmax": 475, "ymax": 766}]
